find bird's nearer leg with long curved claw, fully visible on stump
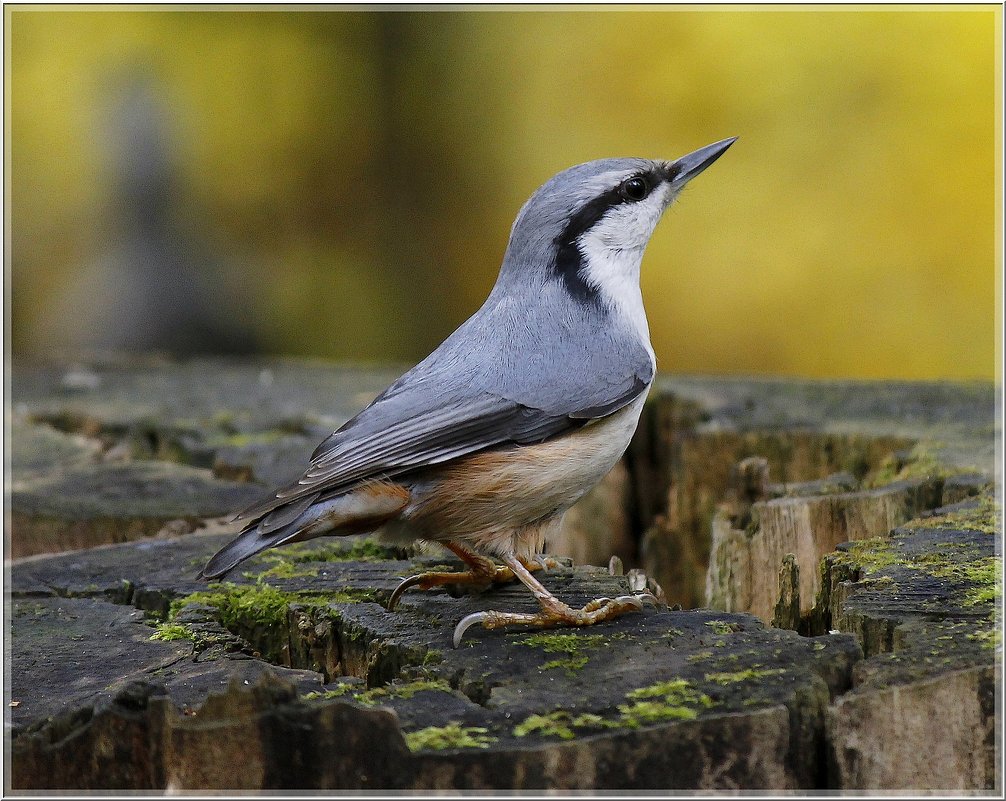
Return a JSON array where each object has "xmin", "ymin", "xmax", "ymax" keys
[{"xmin": 454, "ymin": 555, "xmax": 647, "ymax": 648}]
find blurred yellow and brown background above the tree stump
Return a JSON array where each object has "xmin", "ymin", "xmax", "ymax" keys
[{"xmin": 5, "ymin": 6, "xmax": 1001, "ymax": 378}]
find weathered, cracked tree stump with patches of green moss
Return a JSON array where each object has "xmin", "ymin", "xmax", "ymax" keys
[{"xmin": 7, "ymin": 360, "xmax": 1002, "ymax": 790}]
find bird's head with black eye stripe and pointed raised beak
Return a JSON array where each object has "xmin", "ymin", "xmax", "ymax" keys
[{"xmin": 500, "ymin": 137, "xmax": 736, "ymax": 302}]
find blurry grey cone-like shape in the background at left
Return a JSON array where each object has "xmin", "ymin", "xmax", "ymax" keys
[{"xmin": 41, "ymin": 64, "xmax": 257, "ymax": 355}]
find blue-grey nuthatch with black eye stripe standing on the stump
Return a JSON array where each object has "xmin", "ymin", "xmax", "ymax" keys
[{"xmin": 202, "ymin": 138, "xmax": 735, "ymax": 646}]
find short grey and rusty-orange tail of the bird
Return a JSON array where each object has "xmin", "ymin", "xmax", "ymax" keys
[{"xmin": 196, "ymin": 482, "xmax": 411, "ymax": 579}]
